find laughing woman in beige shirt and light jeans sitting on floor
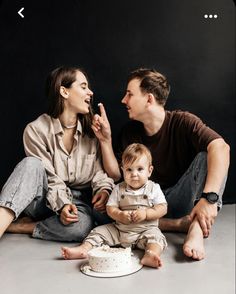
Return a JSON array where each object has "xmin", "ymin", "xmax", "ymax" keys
[{"xmin": 0, "ymin": 67, "xmax": 113, "ymax": 242}]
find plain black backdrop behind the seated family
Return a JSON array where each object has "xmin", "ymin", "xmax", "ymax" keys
[{"xmin": 0, "ymin": 0, "xmax": 236, "ymax": 203}]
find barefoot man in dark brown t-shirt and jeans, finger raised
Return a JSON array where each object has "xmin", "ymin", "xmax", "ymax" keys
[{"xmin": 93, "ymin": 69, "xmax": 230, "ymax": 260}]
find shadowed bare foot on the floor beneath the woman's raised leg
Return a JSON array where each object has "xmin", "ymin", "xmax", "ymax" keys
[{"xmin": 6, "ymin": 216, "xmax": 36, "ymax": 234}]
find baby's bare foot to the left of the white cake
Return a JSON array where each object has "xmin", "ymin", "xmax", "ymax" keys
[{"xmin": 61, "ymin": 243, "xmax": 92, "ymax": 259}]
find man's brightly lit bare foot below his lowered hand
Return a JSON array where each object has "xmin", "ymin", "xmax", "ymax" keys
[{"xmin": 183, "ymin": 219, "xmax": 205, "ymax": 260}]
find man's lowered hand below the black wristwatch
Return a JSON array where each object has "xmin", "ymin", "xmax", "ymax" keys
[{"xmin": 190, "ymin": 198, "xmax": 217, "ymax": 238}]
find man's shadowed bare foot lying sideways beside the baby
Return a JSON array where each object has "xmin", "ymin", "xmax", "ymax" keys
[{"xmin": 159, "ymin": 215, "xmax": 191, "ymax": 233}]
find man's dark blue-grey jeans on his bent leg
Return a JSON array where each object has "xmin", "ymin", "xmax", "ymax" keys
[{"xmin": 163, "ymin": 152, "xmax": 227, "ymax": 218}]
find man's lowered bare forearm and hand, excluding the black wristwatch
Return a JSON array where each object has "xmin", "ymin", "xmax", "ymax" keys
[{"xmin": 190, "ymin": 138, "xmax": 230, "ymax": 237}]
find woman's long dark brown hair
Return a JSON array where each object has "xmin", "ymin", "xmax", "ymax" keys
[{"xmin": 46, "ymin": 66, "xmax": 94, "ymax": 137}]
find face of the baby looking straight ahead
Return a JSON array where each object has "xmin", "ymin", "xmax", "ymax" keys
[{"xmin": 122, "ymin": 155, "xmax": 153, "ymax": 190}]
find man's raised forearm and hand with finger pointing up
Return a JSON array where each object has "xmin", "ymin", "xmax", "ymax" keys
[{"xmin": 92, "ymin": 103, "xmax": 121, "ymax": 181}]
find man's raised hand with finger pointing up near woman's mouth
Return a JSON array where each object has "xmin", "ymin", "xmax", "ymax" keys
[{"xmin": 92, "ymin": 103, "xmax": 111, "ymax": 142}]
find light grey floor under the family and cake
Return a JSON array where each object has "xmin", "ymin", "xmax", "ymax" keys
[{"xmin": 0, "ymin": 205, "xmax": 235, "ymax": 294}]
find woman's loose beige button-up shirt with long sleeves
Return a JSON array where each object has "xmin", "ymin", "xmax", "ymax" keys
[{"xmin": 23, "ymin": 114, "xmax": 114, "ymax": 211}]
